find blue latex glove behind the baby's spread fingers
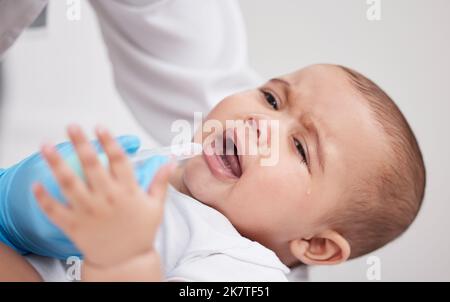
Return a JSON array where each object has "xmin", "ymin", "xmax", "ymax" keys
[{"xmin": 0, "ymin": 136, "xmax": 169, "ymax": 259}]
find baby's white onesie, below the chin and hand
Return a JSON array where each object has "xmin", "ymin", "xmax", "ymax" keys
[{"xmin": 27, "ymin": 186, "xmax": 289, "ymax": 281}]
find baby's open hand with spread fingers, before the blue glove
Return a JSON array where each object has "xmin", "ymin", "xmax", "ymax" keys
[{"xmin": 34, "ymin": 126, "xmax": 174, "ymax": 267}]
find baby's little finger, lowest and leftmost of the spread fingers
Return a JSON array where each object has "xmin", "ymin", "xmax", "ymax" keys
[{"xmin": 33, "ymin": 184, "xmax": 74, "ymax": 234}]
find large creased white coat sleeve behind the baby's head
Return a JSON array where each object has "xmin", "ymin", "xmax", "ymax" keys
[{"xmin": 91, "ymin": 0, "xmax": 261, "ymax": 144}]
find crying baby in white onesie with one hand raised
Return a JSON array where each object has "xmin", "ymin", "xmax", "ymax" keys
[{"xmin": 0, "ymin": 65, "xmax": 425, "ymax": 281}]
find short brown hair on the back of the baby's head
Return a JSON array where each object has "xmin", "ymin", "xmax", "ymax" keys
[{"xmin": 328, "ymin": 66, "xmax": 425, "ymax": 258}]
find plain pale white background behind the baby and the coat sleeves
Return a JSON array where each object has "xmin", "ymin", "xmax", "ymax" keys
[{"xmin": 0, "ymin": 0, "xmax": 450, "ymax": 281}]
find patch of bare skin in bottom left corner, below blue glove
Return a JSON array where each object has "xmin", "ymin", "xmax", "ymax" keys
[{"xmin": 0, "ymin": 242, "xmax": 42, "ymax": 282}]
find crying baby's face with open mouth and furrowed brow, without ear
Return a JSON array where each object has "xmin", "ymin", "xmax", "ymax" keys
[{"xmin": 183, "ymin": 65, "xmax": 382, "ymax": 258}]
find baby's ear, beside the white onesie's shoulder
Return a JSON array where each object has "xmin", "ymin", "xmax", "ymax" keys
[{"xmin": 289, "ymin": 230, "xmax": 350, "ymax": 265}]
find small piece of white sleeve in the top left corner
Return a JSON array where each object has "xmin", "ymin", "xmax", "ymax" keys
[{"xmin": 0, "ymin": 0, "xmax": 48, "ymax": 59}]
